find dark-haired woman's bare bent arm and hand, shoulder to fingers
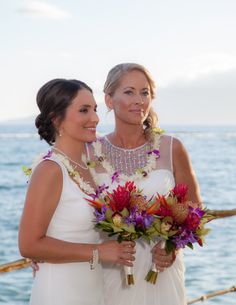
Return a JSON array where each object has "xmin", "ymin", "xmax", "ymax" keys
[{"xmin": 19, "ymin": 160, "xmax": 134, "ymax": 266}]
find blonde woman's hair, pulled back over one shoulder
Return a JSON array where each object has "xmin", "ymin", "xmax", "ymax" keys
[{"xmin": 103, "ymin": 63, "xmax": 158, "ymax": 138}]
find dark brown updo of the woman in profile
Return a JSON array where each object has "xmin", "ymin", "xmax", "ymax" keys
[{"xmin": 35, "ymin": 78, "xmax": 93, "ymax": 145}]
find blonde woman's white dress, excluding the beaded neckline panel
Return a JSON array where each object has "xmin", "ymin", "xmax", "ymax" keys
[{"xmin": 88, "ymin": 136, "xmax": 186, "ymax": 305}]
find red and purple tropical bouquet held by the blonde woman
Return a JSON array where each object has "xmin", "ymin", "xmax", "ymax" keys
[{"xmin": 146, "ymin": 184, "xmax": 210, "ymax": 284}]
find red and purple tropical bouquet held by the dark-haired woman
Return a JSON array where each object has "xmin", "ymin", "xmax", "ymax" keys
[{"xmin": 87, "ymin": 181, "xmax": 155, "ymax": 285}]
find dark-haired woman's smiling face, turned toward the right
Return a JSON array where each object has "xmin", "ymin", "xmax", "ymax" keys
[{"xmin": 59, "ymin": 89, "xmax": 99, "ymax": 142}]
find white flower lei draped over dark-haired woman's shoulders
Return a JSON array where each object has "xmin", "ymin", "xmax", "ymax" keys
[{"xmin": 23, "ymin": 150, "xmax": 94, "ymax": 194}]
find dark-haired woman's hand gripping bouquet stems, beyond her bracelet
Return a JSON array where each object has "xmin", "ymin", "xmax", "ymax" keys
[{"xmin": 97, "ymin": 240, "xmax": 135, "ymax": 267}]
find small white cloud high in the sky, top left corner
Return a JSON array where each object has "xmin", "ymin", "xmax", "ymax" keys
[{"xmin": 17, "ymin": 1, "xmax": 70, "ymax": 20}]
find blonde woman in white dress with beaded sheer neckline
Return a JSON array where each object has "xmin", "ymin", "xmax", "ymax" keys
[{"xmin": 90, "ymin": 63, "xmax": 201, "ymax": 305}]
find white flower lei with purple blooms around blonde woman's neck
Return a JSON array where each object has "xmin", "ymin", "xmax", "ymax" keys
[{"xmin": 87, "ymin": 128, "xmax": 164, "ymax": 183}]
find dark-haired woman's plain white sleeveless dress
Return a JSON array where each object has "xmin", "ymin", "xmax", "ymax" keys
[{"xmin": 30, "ymin": 156, "xmax": 104, "ymax": 305}]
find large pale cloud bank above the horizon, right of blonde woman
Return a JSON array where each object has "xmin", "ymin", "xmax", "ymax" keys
[{"xmin": 155, "ymin": 69, "xmax": 236, "ymax": 125}]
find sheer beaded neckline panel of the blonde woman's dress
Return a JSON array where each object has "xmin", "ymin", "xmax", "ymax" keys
[{"xmin": 103, "ymin": 137, "xmax": 151, "ymax": 175}]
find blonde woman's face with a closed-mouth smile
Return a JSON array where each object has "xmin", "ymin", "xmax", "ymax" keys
[{"xmin": 105, "ymin": 70, "xmax": 152, "ymax": 125}]
